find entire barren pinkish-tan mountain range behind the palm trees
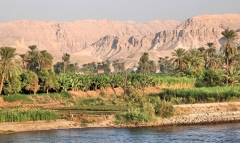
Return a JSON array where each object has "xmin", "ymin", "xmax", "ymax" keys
[{"xmin": 0, "ymin": 14, "xmax": 240, "ymax": 67}]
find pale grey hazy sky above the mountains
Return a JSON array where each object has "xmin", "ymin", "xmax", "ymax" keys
[{"xmin": 0, "ymin": 0, "xmax": 240, "ymax": 23}]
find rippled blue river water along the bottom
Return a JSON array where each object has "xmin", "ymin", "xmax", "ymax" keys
[{"xmin": 0, "ymin": 123, "xmax": 240, "ymax": 143}]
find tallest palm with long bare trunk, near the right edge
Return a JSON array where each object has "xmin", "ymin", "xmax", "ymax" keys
[{"xmin": 221, "ymin": 29, "xmax": 238, "ymax": 85}]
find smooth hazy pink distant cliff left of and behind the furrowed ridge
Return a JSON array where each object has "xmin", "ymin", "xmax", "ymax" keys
[{"xmin": 0, "ymin": 19, "xmax": 179, "ymax": 53}]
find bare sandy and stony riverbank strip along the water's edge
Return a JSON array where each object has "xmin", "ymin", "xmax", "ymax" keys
[{"xmin": 0, "ymin": 102, "xmax": 240, "ymax": 134}]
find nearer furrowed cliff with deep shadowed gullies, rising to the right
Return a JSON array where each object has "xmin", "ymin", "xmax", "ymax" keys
[{"xmin": 82, "ymin": 14, "xmax": 240, "ymax": 67}]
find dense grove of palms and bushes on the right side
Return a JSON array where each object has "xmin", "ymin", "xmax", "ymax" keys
[{"xmin": 158, "ymin": 29, "xmax": 240, "ymax": 86}]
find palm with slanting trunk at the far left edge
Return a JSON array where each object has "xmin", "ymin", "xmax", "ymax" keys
[{"xmin": 0, "ymin": 47, "xmax": 17, "ymax": 94}]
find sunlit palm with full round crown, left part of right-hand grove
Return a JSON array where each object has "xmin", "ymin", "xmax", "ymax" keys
[{"xmin": 171, "ymin": 48, "xmax": 187, "ymax": 72}]
